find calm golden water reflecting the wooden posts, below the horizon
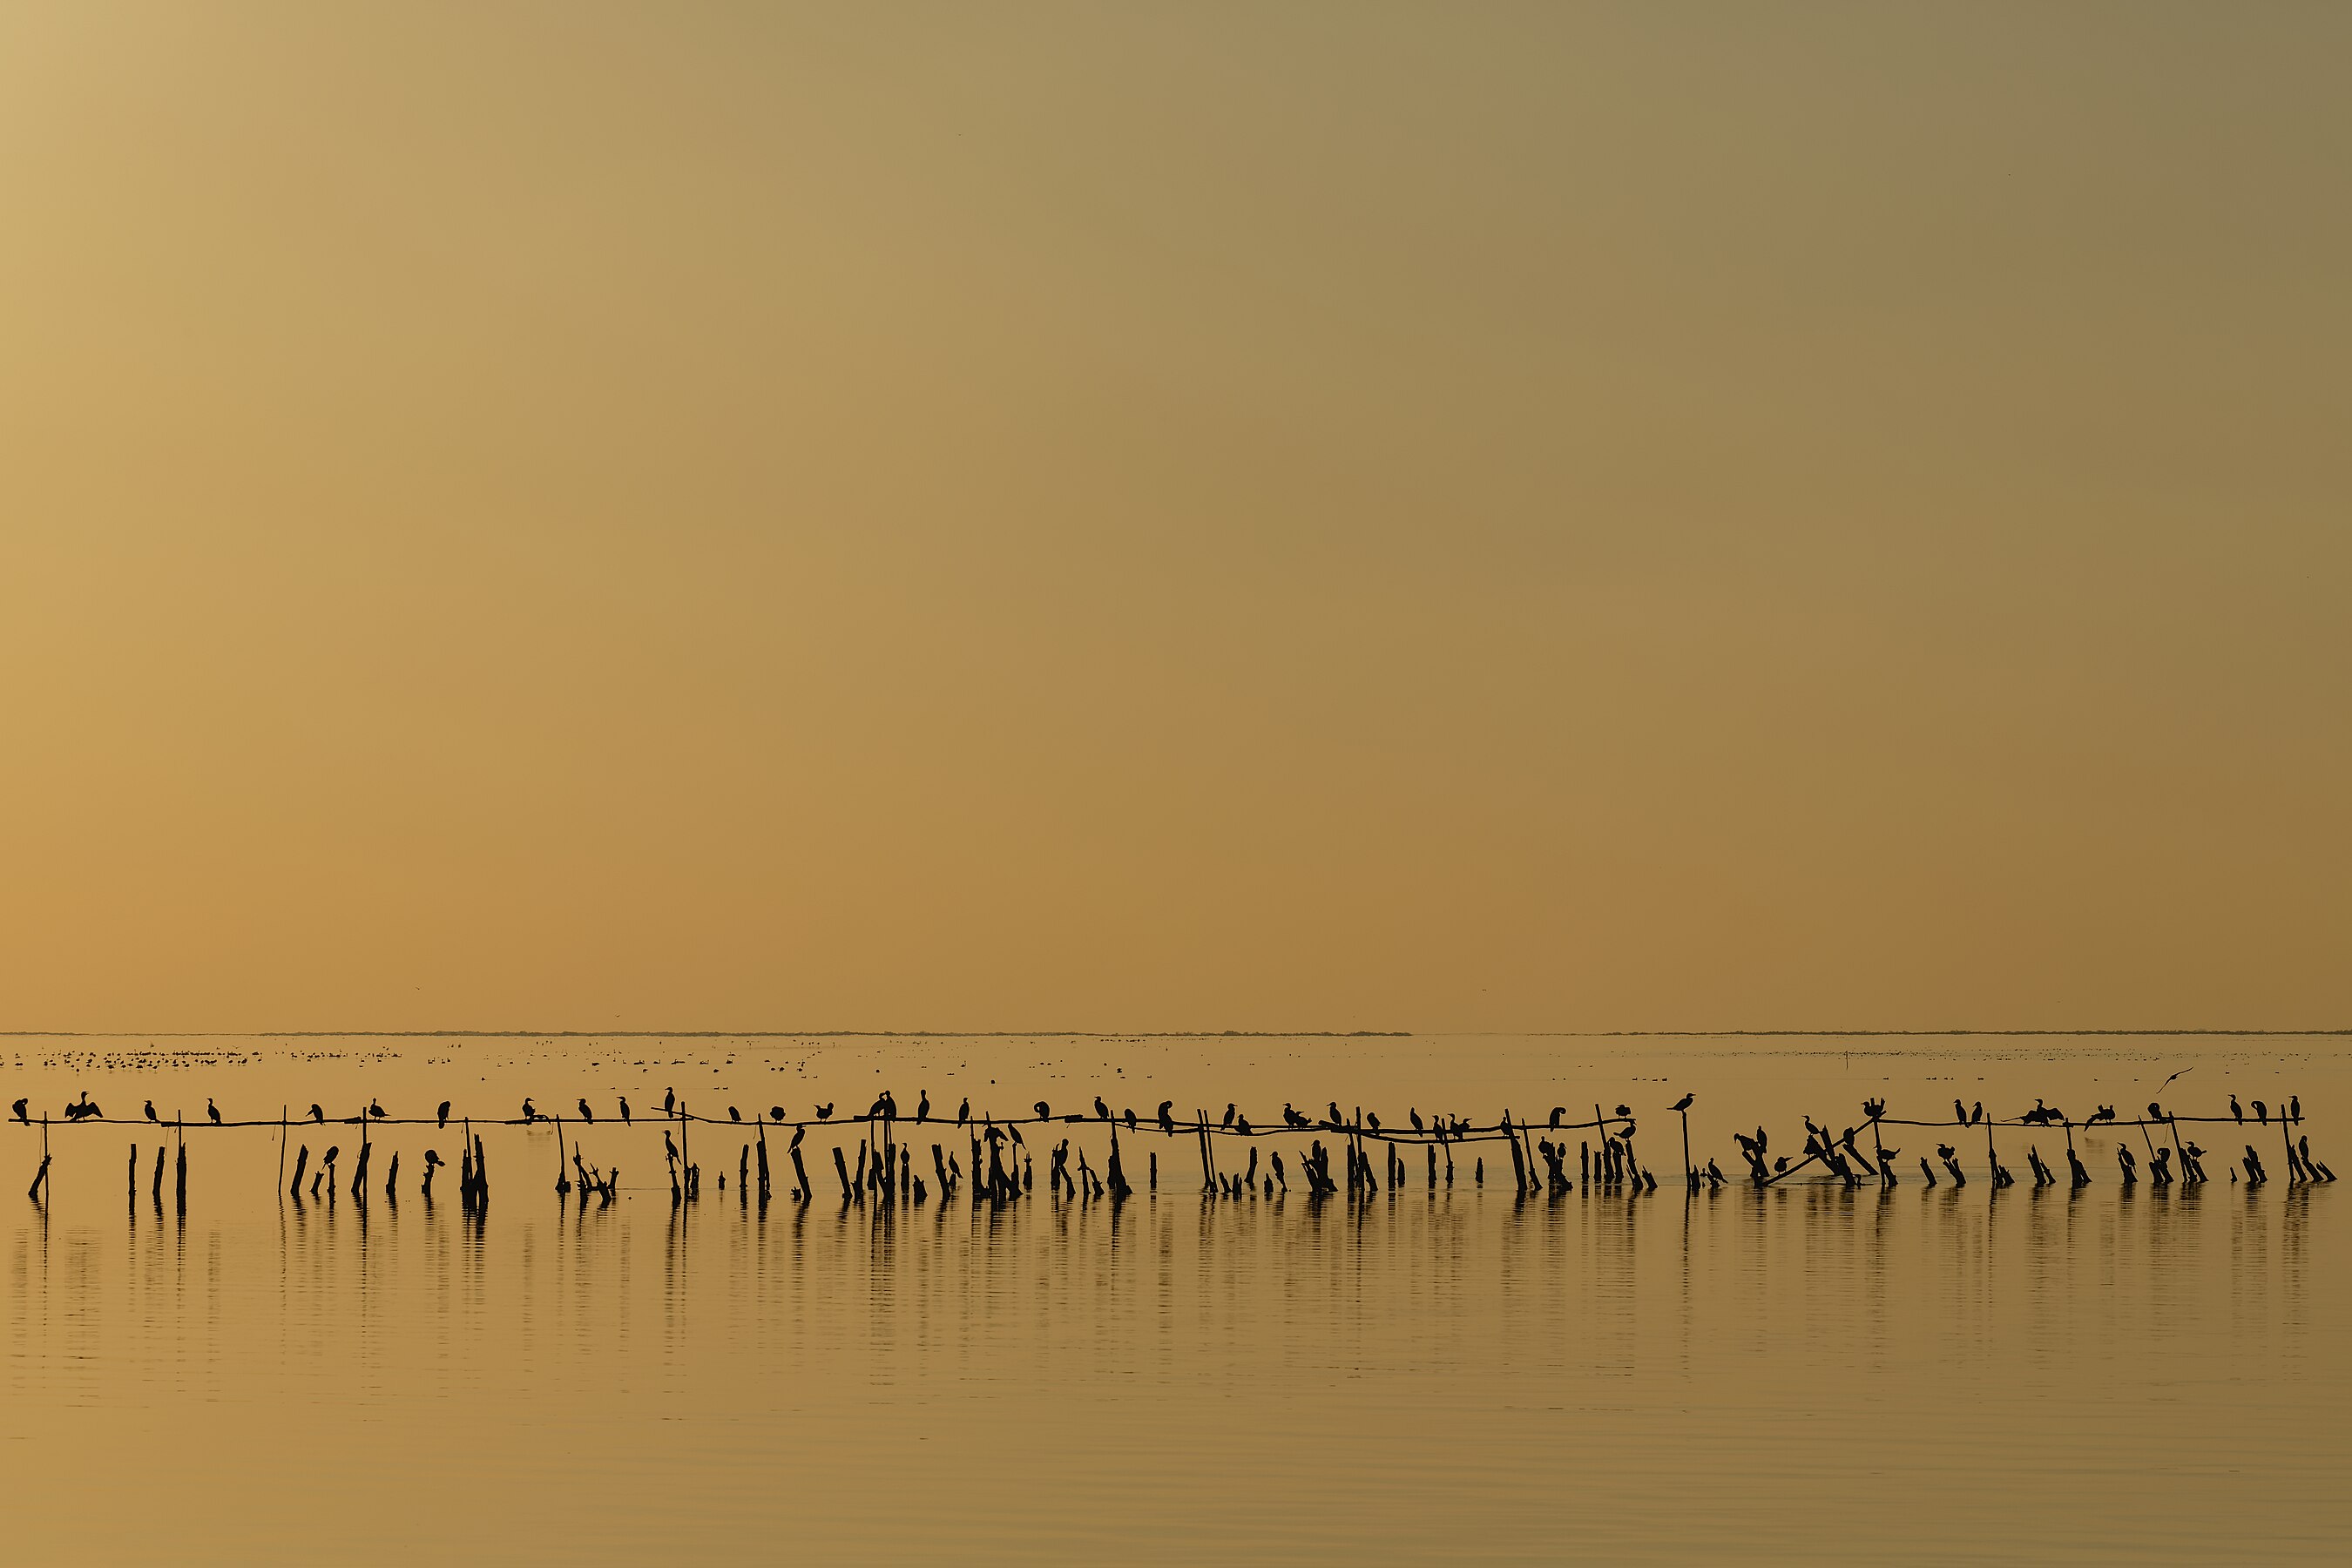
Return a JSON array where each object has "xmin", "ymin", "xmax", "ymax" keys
[{"xmin": 0, "ymin": 1037, "xmax": 2352, "ymax": 1564}]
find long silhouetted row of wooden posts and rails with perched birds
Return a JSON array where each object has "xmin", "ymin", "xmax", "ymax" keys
[{"xmin": 10, "ymin": 1074, "xmax": 2335, "ymax": 1204}]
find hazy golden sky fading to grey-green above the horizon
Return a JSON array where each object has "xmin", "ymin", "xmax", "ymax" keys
[{"xmin": 0, "ymin": 3, "xmax": 2352, "ymax": 1030}]
